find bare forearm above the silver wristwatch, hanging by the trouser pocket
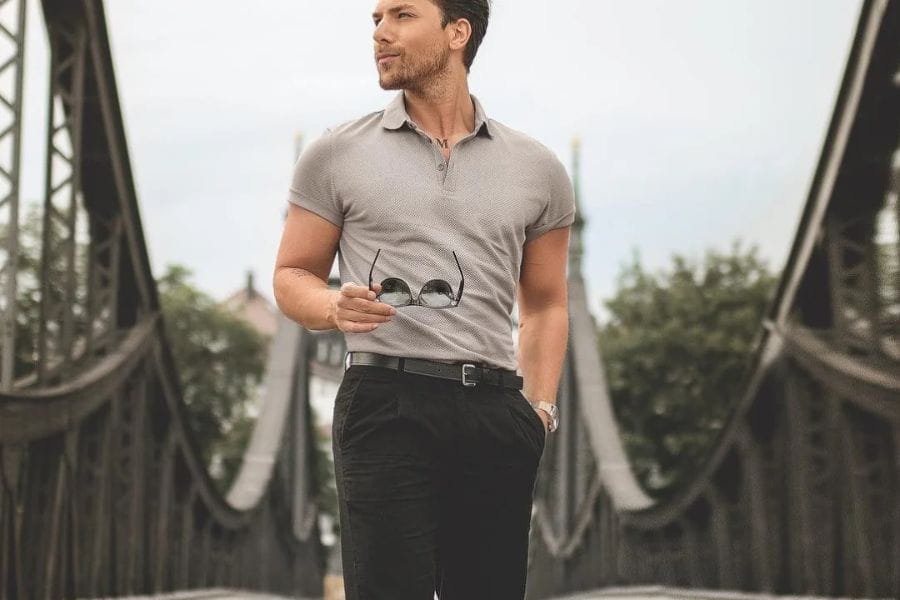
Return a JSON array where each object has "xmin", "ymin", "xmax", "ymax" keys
[{"xmin": 518, "ymin": 305, "xmax": 569, "ymax": 403}]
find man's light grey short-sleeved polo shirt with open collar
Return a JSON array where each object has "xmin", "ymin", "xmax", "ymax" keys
[{"xmin": 288, "ymin": 90, "xmax": 575, "ymax": 370}]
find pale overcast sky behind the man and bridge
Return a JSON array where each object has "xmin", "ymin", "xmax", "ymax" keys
[{"xmin": 17, "ymin": 0, "xmax": 859, "ymax": 322}]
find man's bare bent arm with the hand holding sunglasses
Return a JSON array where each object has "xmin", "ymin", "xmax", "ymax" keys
[{"xmin": 272, "ymin": 203, "xmax": 396, "ymax": 332}]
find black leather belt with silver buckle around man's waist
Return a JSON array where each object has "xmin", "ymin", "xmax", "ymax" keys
[{"xmin": 344, "ymin": 352, "xmax": 522, "ymax": 390}]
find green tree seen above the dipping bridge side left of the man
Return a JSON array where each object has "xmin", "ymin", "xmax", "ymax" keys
[{"xmin": 157, "ymin": 265, "xmax": 268, "ymax": 492}]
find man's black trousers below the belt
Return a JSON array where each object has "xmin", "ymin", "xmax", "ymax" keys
[{"xmin": 332, "ymin": 365, "xmax": 546, "ymax": 600}]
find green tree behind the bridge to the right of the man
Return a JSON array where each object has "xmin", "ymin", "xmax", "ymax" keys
[{"xmin": 600, "ymin": 241, "xmax": 776, "ymax": 498}]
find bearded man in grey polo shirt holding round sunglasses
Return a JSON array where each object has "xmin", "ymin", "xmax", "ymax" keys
[{"xmin": 273, "ymin": 0, "xmax": 575, "ymax": 600}]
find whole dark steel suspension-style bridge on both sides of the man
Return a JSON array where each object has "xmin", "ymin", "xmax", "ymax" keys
[{"xmin": 0, "ymin": 0, "xmax": 900, "ymax": 600}]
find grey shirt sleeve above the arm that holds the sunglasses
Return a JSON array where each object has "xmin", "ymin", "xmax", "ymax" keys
[{"xmin": 288, "ymin": 129, "xmax": 344, "ymax": 227}]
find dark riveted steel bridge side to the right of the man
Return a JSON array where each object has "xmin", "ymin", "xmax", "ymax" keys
[{"xmin": 528, "ymin": 0, "xmax": 900, "ymax": 598}]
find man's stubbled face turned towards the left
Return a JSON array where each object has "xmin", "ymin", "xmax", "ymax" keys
[{"xmin": 372, "ymin": 0, "xmax": 450, "ymax": 90}]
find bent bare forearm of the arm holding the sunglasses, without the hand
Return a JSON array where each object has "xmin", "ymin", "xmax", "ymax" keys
[{"xmin": 273, "ymin": 267, "xmax": 340, "ymax": 331}]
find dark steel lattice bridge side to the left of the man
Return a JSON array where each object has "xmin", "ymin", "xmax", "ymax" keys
[{"xmin": 0, "ymin": 0, "xmax": 325, "ymax": 599}]
